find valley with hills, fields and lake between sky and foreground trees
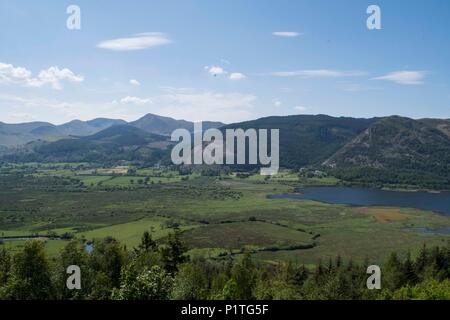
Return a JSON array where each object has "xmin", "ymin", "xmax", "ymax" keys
[{"xmin": 0, "ymin": 114, "xmax": 450, "ymax": 268}]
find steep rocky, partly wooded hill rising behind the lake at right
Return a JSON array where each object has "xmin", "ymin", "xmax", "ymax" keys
[{"xmin": 324, "ymin": 117, "xmax": 450, "ymax": 188}]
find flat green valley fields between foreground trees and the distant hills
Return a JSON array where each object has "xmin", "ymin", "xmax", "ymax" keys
[{"xmin": 0, "ymin": 164, "xmax": 450, "ymax": 265}]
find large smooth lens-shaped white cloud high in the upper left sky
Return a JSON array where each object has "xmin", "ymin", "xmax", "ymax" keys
[{"xmin": 97, "ymin": 32, "xmax": 172, "ymax": 51}]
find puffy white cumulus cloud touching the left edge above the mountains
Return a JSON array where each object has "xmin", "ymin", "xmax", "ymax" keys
[{"xmin": 0, "ymin": 62, "xmax": 84, "ymax": 90}]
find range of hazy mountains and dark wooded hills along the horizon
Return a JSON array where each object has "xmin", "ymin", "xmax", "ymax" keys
[{"xmin": 0, "ymin": 114, "xmax": 450, "ymax": 188}]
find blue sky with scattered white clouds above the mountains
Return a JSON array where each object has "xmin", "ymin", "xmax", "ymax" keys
[{"xmin": 0, "ymin": 0, "xmax": 450, "ymax": 123}]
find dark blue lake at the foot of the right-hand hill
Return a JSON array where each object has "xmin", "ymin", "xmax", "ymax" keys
[{"xmin": 271, "ymin": 187, "xmax": 450, "ymax": 215}]
